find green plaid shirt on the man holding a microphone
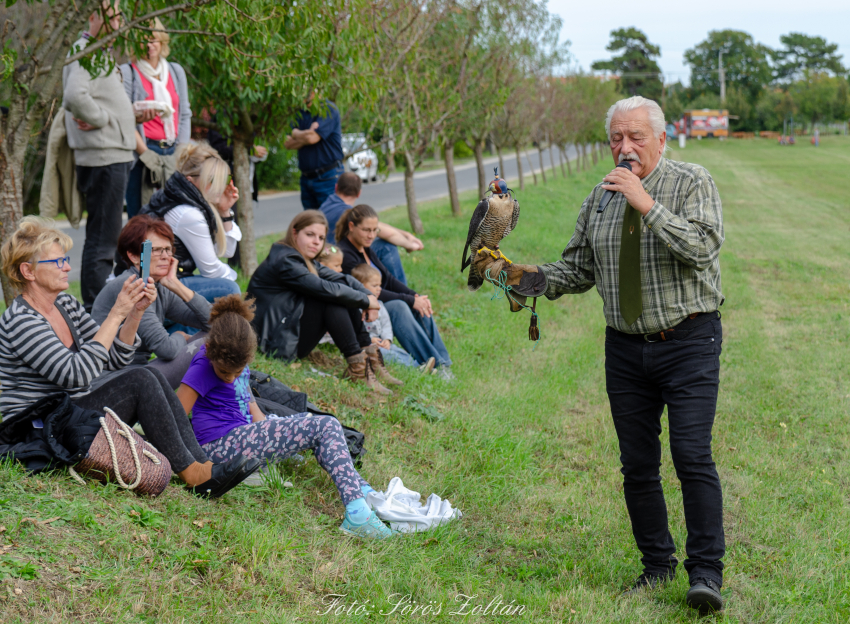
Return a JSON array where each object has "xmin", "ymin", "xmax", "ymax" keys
[{"xmin": 541, "ymin": 157, "xmax": 724, "ymax": 334}]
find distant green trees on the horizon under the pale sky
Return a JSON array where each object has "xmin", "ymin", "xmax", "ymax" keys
[{"xmin": 592, "ymin": 28, "xmax": 850, "ymax": 131}]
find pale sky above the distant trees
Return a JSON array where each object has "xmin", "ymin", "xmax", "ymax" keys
[{"xmin": 549, "ymin": 0, "xmax": 850, "ymax": 84}]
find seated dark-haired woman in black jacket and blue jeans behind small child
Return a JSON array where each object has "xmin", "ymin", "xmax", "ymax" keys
[{"xmin": 335, "ymin": 204, "xmax": 454, "ymax": 381}]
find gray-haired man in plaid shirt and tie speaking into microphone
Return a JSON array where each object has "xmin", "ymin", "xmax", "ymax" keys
[{"xmin": 475, "ymin": 96, "xmax": 725, "ymax": 612}]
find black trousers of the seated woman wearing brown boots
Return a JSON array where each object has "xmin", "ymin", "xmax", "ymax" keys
[{"xmin": 298, "ymin": 297, "xmax": 372, "ymax": 359}]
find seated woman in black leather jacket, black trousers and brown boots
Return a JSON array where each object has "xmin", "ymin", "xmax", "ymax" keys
[{"xmin": 243, "ymin": 210, "xmax": 391, "ymax": 394}]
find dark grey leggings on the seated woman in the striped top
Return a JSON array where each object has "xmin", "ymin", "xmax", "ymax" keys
[{"xmin": 73, "ymin": 366, "xmax": 209, "ymax": 472}]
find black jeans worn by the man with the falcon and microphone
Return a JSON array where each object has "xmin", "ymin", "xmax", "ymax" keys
[{"xmin": 605, "ymin": 319, "xmax": 726, "ymax": 584}]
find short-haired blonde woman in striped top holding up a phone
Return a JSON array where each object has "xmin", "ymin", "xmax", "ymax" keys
[{"xmin": 0, "ymin": 217, "xmax": 259, "ymax": 497}]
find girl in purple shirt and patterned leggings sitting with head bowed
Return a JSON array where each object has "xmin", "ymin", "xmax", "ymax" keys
[{"xmin": 177, "ymin": 295, "xmax": 393, "ymax": 538}]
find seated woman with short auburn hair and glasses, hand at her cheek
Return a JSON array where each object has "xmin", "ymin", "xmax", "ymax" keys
[{"xmin": 91, "ymin": 215, "xmax": 210, "ymax": 390}]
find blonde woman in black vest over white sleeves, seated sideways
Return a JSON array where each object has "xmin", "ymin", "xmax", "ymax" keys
[{"xmin": 142, "ymin": 143, "xmax": 242, "ymax": 302}]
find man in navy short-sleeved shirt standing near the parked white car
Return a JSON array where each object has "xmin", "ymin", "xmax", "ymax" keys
[{"xmin": 283, "ymin": 96, "xmax": 345, "ymax": 210}]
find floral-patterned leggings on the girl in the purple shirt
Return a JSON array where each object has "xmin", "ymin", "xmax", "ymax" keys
[{"xmin": 201, "ymin": 413, "xmax": 369, "ymax": 505}]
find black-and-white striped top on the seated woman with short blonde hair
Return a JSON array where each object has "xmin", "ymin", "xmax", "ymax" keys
[{"xmin": 0, "ymin": 293, "xmax": 141, "ymax": 418}]
